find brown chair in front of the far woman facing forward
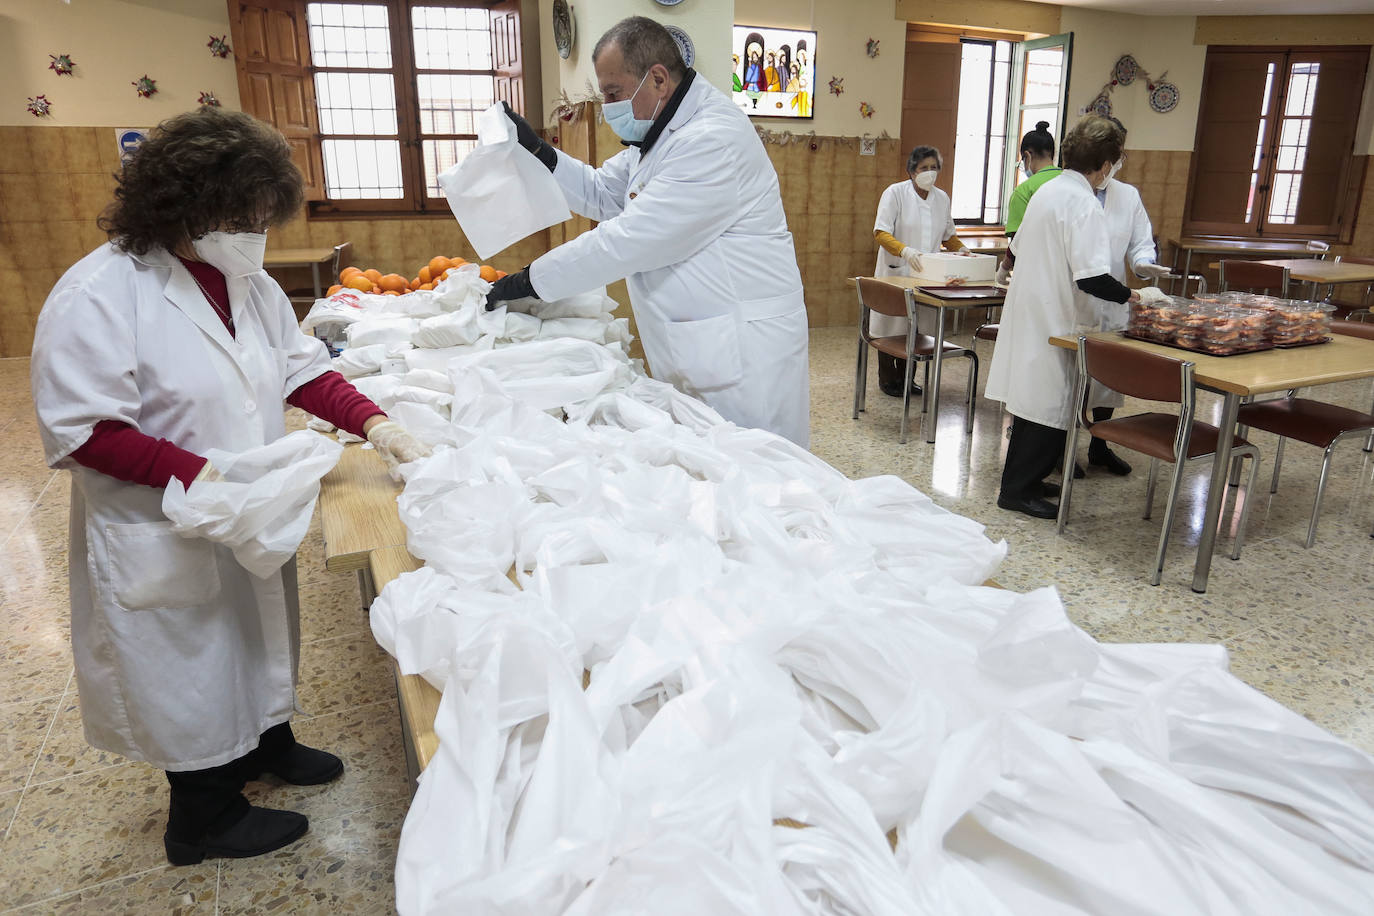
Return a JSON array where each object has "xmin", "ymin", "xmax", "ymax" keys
[{"xmin": 853, "ymin": 277, "xmax": 978, "ymax": 445}]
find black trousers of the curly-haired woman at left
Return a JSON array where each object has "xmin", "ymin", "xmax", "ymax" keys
[{"xmin": 166, "ymin": 722, "xmax": 295, "ymax": 842}]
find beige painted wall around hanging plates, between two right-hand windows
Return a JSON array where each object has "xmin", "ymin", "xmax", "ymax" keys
[{"xmin": 1059, "ymin": 7, "xmax": 1206, "ymax": 150}]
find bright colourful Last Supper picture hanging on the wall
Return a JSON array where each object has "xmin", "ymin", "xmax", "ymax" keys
[{"xmin": 731, "ymin": 26, "xmax": 816, "ymax": 118}]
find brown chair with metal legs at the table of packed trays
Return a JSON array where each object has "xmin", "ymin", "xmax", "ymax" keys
[{"xmin": 1059, "ymin": 336, "xmax": 1260, "ymax": 585}]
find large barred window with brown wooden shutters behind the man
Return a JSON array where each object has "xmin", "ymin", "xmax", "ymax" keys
[{"xmin": 231, "ymin": 0, "xmax": 523, "ymax": 214}]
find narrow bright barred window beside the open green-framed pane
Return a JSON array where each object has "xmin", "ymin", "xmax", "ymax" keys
[{"xmin": 949, "ymin": 38, "xmax": 1011, "ymax": 225}]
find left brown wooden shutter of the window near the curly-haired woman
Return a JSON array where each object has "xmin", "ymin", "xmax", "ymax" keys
[{"xmin": 229, "ymin": 0, "xmax": 324, "ymax": 201}]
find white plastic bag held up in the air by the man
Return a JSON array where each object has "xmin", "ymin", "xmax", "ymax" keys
[{"xmin": 438, "ymin": 102, "xmax": 572, "ymax": 260}]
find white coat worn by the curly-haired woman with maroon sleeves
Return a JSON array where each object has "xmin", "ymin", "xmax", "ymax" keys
[{"xmin": 32, "ymin": 244, "xmax": 330, "ymax": 770}]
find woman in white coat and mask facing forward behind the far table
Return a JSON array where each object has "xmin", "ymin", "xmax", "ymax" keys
[{"xmin": 868, "ymin": 146, "xmax": 971, "ymax": 397}]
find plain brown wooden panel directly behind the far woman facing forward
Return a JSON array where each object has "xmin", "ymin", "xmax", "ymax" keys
[{"xmin": 893, "ymin": 41, "xmax": 962, "ymax": 194}]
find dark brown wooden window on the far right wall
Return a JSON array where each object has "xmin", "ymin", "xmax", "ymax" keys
[{"xmin": 1184, "ymin": 48, "xmax": 1369, "ymax": 240}]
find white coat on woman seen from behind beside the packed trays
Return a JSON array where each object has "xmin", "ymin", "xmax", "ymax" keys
[{"xmin": 987, "ymin": 169, "xmax": 1112, "ymax": 430}]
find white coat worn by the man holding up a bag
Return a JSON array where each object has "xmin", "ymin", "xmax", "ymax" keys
[{"xmin": 530, "ymin": 76, "xmax": 811, "ymax": 446}]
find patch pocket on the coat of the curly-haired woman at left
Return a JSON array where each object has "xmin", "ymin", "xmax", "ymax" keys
[{"xmin": 104, "ymin": 522, "xmax": 220, "ymax": 611}]
